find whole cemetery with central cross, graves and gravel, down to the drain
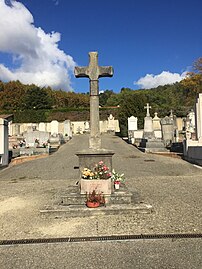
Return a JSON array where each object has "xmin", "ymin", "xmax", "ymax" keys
[{"xmin": 0, "ymin": 52, "xmax": 202, "ymax": 268}]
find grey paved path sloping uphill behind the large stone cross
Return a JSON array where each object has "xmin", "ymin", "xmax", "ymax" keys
[{"xmin": 0, "ymin": 132, "xmax": 202, "ymax": 180}]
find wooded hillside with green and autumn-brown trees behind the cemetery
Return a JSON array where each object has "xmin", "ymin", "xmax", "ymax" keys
[{"xmin": 0, "ymin": 64, "xmax": 202, "ymax": 136}]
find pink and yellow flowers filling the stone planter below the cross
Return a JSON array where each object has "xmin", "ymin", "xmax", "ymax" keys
[{"xmin": 82, "ymin": 161, "xmax": 111, "ymax": 179}]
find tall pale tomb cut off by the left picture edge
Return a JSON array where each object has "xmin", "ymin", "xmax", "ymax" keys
[{"xmin": 0, "ymin": 118, "xmax": 9, "ymax": 166}]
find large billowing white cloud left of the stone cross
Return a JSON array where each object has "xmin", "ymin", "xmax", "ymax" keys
[{"xmin": 0, "ymin": 0, "xmax": 75, "ymax": 90}]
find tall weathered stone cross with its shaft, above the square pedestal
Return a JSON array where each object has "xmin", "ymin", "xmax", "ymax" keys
[{"xmin": 74, "ymin": 52, "xmax": 113, "ymax": 150}]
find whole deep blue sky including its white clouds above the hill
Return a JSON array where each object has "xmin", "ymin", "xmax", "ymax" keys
[{"xmin": 0, "ymin": 0, "xmax": 202, "ymax": 92}]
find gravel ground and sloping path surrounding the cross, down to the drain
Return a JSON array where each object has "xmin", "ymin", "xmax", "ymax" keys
[{"xmin": 0, "ymin": 135, "xmax": 202, "ymax": 240}]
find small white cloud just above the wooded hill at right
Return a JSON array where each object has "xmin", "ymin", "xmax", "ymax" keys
[{"xmin": 134, "ymin": 71, "xmax": 187, "ymax": 89}]
